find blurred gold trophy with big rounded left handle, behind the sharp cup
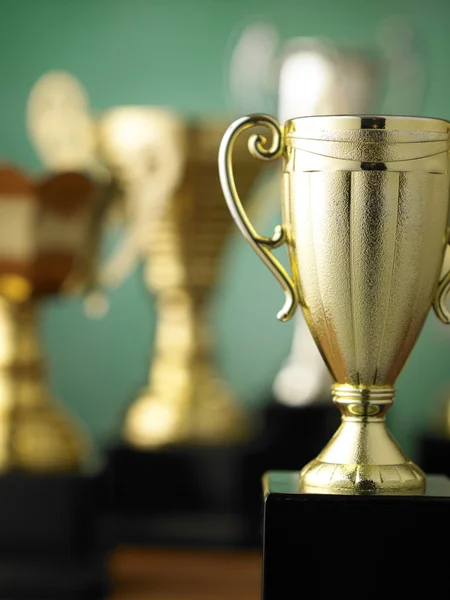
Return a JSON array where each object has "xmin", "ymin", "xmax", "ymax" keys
[{"xmin": 29, "ymin": 72, "xmax": 260, "ymax": 449}]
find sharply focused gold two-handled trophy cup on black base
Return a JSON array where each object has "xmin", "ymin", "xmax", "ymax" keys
[{"xmin": 219, "ymin": 115, "xmax": 450, "ymax": 494}]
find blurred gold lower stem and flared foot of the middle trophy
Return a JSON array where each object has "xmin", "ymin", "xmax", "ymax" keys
[{"xmin": 124, "ymin": 287, "xmax": 248, "ymax": 448}]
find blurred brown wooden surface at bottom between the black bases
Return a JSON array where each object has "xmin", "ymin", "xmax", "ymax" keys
[{"xmin": 110, "ymin": 548, "xmax": 261, "ymax": 600}]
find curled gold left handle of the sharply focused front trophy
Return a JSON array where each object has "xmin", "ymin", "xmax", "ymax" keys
[{"xmin": 219, "ymin": 114, "xmax": 298, "ymax": 321}]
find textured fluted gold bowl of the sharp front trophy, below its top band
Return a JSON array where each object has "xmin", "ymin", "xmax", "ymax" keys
[{"xmin": 286, "ymin": 119, "xmax": 449, "ymax": 386}]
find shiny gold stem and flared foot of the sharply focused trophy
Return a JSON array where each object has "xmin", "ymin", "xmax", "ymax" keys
[{"xmin": 300, "ymin": 384, "xmax": 425, "ymax": 495}]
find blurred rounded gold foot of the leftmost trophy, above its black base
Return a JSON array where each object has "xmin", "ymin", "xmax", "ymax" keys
[{"xmin": 0, "ymin": 402, "xmax": 90, "ymax": 473}]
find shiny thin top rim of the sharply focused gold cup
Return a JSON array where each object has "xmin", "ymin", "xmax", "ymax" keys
[{"xmin": 285, "ymin": 114, "xmax": 450, "ymax": 133}]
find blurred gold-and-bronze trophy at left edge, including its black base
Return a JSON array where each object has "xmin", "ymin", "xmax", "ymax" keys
[{"xmin": 0, "ymin": 165, "xmax": 111, "ymax": 597}]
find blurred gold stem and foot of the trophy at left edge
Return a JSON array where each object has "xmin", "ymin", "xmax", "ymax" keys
[{"xmin": 0, "ymin": 299, "xmax": 86, "ymax": 472}]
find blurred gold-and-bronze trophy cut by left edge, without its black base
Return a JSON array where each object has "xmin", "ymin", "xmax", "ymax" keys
[{"xmin": 0, "ymin": 165, "xmax": 106, "ymax": 472}]
